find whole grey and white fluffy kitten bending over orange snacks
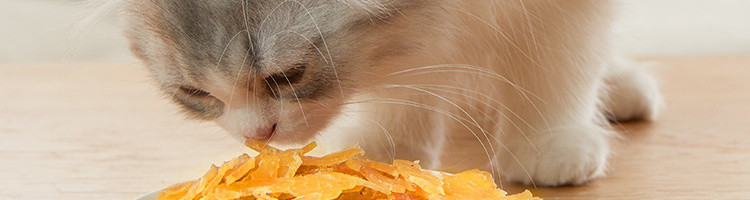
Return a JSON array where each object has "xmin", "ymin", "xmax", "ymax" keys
[{"xmin": 129, "ymin": 0, "xmax": 659, "ymax": 186}]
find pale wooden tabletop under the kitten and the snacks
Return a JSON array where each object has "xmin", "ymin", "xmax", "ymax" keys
[{"xmin": 0, "ymin": 56, "xmax": 750, "ymax": 199}]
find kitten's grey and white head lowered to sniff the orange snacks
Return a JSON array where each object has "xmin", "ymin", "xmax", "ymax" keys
[{"xmin": 127, "ymin": 0, "xmax": 438, "ymax": 142}]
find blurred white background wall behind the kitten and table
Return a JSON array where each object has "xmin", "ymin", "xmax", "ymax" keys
[{"xmin": 0, "ymin": 0, "xmax": 750, "ymax": 63}]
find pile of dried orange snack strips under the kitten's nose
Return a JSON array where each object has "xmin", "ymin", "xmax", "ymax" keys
[{"xmin": 159, "ymin": 141, "xmax": 539, "ymax": 200}]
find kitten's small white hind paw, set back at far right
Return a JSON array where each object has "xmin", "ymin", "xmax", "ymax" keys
[{"xmin": 602, "ymin": 59, "xmax": 663, "ymax": 121}]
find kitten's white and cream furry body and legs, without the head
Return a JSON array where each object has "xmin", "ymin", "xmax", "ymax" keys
[{"xmin": 323, "ymin": 0, "xmax": 659, "ymax": 186}]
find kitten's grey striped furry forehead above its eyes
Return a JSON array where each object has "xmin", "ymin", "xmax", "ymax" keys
[{"xmin": 130, "ymin": 0, "xmax": 408, "ymax": 86}]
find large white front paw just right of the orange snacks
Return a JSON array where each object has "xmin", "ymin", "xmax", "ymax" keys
[{"xmin": 500, "ymin": 127, "xmax": 609, "ymax": 186}]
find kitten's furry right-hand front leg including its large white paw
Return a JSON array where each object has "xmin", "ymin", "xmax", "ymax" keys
[{"xmin": 496, "ymin": 52, "xmax": 611, "ymax": 186}]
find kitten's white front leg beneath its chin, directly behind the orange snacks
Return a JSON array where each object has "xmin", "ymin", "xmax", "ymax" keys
[{"xmin": 321, "ymin": 97, "xmax": 442, "ymax": 167}]
